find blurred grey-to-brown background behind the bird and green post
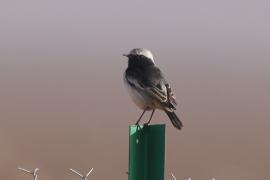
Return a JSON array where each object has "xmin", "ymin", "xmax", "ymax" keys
[{"xmin": 0, "ymin": 0, "xmax": 270, "ymax": 180}]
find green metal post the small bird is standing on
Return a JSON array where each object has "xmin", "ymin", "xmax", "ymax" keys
[{"xmin": 128, "ymin": 124, "xmax": 166, "ymax": 180}]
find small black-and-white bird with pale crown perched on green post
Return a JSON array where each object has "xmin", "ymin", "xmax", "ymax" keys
[{"xmin": 123, "ymin": 48, "xmax": 183, "ymax": 130}]
